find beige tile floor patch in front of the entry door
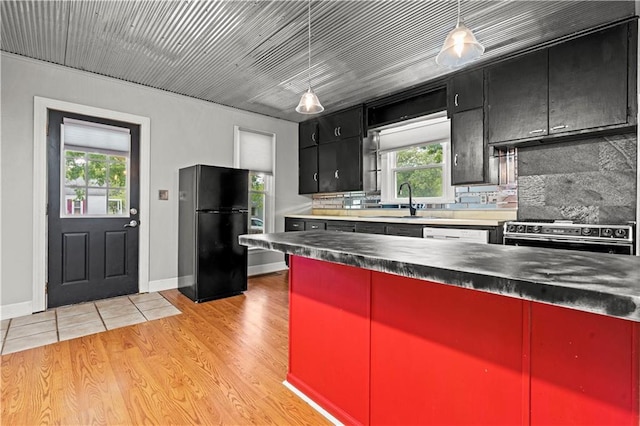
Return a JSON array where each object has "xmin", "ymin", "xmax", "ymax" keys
[{"xmin": 0, "ymin": 293, "xmax": 180, "ymax": 355}]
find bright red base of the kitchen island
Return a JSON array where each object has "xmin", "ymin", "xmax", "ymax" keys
[{"xmin": 287, "ymin": 256, "xmax": 640, "ymax": 426}]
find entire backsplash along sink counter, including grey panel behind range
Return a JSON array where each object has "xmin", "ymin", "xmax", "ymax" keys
[{"xmin": 312, "ymin": 133, "xmax": 638, "ymax": 224}]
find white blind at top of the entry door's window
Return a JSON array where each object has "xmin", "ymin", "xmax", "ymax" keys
[{"xmin": 62, "ymin": 118, "xmax": 131, "ymax": 153}]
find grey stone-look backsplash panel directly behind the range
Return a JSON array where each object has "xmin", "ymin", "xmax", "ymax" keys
[{"xmin": 517, "ymin": 133, "xmax": 638, "ymax": 224}]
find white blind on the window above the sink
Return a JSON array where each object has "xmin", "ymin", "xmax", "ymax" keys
[{"xmin": 379, "ymin": 113, "xmax": 451, "ymax": 152}]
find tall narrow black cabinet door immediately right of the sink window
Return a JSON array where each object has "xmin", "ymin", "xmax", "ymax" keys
[{"xmin": 451, "ymin": 108, "xmax": 488, "ymax": 185}]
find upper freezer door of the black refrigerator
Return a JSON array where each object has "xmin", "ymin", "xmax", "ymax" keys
[{"xmin": 196, "ymin": 166, "xmax": 249, "ymax": 210}]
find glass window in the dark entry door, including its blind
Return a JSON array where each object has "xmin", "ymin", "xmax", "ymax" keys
[{"xmin": 60, "ymin": 119, "xmax": 129, "ymax": 217}]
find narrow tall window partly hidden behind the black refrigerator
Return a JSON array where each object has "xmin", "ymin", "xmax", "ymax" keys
[{"xmin": 234, "ymin": 126, "xmax": 276, "ymax": 234}]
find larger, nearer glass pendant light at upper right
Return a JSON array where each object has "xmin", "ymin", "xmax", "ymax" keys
[{"xmin": 436, "ymin": 0, "xmax": 484, "ymax": 67}]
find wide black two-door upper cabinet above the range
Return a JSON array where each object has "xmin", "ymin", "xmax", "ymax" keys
[{"xmin": 485, "ymin": 22, "xmax": 637, "ymax": 145}]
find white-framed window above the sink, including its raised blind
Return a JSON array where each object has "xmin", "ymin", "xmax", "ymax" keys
[{"xmin": 379, "ymin": 112, "xmax": 455, "ymax": 204}]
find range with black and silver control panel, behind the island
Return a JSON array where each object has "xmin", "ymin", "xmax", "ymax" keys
[{"xmin": 503, "ymin": 221, "xmax": 635, "ymax": 255}]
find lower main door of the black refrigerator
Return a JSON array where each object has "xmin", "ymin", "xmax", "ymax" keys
[{"xmin": 196, "ymin": 212, "xmax": 248, "ymax": 302}]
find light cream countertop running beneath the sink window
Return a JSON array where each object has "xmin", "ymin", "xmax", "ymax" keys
[{"xmin": 285, "ymin": 214, "xmax": 505, "ymax": 226}]
